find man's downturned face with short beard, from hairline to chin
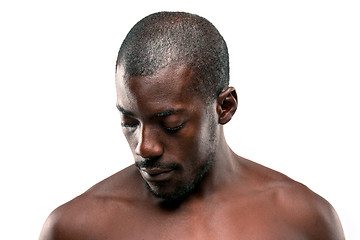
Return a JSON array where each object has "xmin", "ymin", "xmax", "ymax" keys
[{"xmin": 116, "ymin": 66, "xmax": 217, "ymax": 200}]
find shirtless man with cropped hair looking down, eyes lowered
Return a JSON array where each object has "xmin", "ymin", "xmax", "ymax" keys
[{"xmin": 40, "ymin": 12, "xmax": 344, "ymax": 240}]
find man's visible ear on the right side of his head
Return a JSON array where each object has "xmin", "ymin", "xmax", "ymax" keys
[{"xmin": 216, "ymin": 87, "xmax": 237, "ymax": 125}]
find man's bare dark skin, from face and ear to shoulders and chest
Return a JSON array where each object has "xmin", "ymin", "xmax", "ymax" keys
[{"xmin": 40, "ymin": 65, "xmax": 344, "ymax": 240}]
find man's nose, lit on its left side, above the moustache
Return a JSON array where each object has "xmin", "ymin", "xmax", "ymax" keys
[{"xmin": 135, "ymin": 125, "xmax": 163, "ymax": 159}]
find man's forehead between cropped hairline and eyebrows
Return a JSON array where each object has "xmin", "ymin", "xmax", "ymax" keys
[{"xmin": 116, "ymin": 65, "xmax": 202, "ymax": 114}]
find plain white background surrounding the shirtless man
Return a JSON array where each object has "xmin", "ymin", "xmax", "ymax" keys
[{"xmin": 0, "ymin": 0, "xmax": 360, "ymax": 239}]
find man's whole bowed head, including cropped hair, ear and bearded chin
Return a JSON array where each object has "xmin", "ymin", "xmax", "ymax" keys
[{"xmin": 116, "ymin": 12, "xmax": 236, "ymax": 201}]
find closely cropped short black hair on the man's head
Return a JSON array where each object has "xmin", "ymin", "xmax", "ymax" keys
[{"xmin": 116, "ymin": 12, "xmax": 229, "ymax": 102}]
